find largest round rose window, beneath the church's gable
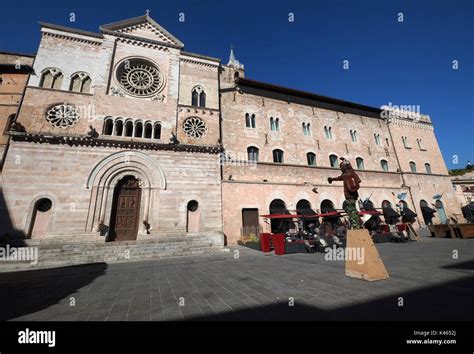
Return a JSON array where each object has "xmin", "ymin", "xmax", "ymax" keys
[{"xmin": 117, "ymin": 59, "xmax": 164, "ymax": 97}]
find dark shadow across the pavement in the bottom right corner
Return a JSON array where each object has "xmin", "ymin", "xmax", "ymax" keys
[{"xmin": 186, "ymin": 277, "xmax": 474, "ymax": 322}]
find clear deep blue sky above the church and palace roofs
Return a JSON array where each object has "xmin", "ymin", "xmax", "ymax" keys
[{"xmin": 0, "ymin": 0, "xmax": 474, "ymax": 168}]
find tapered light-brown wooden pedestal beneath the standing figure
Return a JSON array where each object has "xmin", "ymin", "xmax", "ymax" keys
[{"xmin": 346, "ymin": 229, "xmax": 390, "ymax": 281}]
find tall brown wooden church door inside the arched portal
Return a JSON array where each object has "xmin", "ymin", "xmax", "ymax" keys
[{"xmin": 110, "ymin": 176, "xmax": 141, "ymax": 241}]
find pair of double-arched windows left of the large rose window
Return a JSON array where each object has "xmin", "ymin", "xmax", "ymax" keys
[{"xmin": 39, "ymin": 68, "xmax": 92, "ymax": 93}]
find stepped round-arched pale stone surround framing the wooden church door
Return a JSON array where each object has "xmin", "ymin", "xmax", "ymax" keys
[{"xmin": 86, "ymin": 151, "xmax": 166, "ymax": 235}]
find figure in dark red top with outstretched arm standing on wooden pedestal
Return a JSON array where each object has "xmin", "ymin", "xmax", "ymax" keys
[{"xmin": 328, "ymin": 157, "xmax": 361, "ymax": 230}]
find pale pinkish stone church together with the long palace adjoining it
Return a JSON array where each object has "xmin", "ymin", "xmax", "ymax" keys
[{"xmin": 0, "ymin": 15, "xmax": 461, "ymax": 247}]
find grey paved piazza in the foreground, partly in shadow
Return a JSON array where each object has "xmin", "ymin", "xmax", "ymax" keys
[{"xmin": 0, "ymin": 238, "xmax": 474, "ymax": 321}]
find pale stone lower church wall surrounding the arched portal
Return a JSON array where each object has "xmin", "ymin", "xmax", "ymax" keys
[{"xmin": 0, "ymin": 142, "xmax": 222, "ymax": 238}]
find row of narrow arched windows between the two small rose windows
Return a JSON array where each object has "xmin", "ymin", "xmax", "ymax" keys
[{"xmin": 103, "ymin": 117, "xmax": 161, "ymax": 139}]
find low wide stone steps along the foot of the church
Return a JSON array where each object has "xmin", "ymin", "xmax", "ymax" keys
[{"xmin": 0, "ymin": 236, "xmax": 224, "ymax": 272}]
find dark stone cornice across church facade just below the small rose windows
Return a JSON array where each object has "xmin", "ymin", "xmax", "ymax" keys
[{"xmin": 8, "ymin": 131, "xmax": 223, "ymax": 154}]
